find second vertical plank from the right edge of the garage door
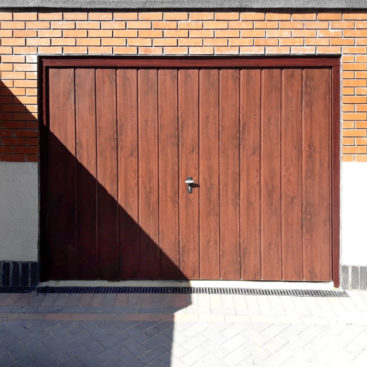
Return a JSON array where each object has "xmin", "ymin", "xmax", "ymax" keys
[{"xmin": 281, "ymin": 69, "xmax": 303, "ymax": 280}]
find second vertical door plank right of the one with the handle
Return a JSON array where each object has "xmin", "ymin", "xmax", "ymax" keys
[{"xmin": 219, "ymin": 69, "xmax": 240, "ymax": 279}]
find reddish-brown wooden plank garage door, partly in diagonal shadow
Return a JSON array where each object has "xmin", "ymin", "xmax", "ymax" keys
[{"xmin": 42, "ymin": 60, "xmax": 340, "ymax": 281}]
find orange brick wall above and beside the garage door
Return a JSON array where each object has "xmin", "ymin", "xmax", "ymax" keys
[{"xmin": 0, "ymin": 12, "xmax": 367, "ymax": 161}]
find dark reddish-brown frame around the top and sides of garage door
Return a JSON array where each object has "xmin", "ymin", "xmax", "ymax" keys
[{"xmin": 38, "ymin": 56, "xmax": 340, "ymax": 288}]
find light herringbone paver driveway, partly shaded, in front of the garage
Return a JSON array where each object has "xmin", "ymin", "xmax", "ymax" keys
[{"xmin": 0, "ymin": 291, "xmax": 367, "ymax": 367}]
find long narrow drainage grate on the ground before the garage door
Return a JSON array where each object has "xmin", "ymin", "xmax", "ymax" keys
[{"xmin": 0, "ymin": 287, "xmax": 349, "ymax": 297}]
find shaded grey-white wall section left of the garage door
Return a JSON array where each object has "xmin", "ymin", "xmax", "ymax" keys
[{"xmin": 0, "ymin": 162, "xmax": 39, "ymax": 261}]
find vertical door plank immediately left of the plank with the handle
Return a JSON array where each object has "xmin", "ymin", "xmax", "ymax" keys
[{"xmin": 158, "ymin": 69, "xmax": 180, "ymax": 279}]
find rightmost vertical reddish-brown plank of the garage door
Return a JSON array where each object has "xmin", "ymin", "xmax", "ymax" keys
[{"xmin": 303, "ymin": 69, "xmax": 331, "ymax": 280}]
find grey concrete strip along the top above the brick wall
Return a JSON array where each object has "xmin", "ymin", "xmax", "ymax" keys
[{"xmin": 0, "ymin": 0, "xmax": 367, "ymax": 10}]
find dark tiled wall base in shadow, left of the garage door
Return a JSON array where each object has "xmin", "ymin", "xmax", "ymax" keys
[{"xmin": 0, "ymin": 261, "xmax": 39, "ymax": 287}]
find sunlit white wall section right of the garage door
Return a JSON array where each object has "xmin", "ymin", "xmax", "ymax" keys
[{"xmin": 341, "ymin": 162, "xmax": 367, "ymax": 266}]
